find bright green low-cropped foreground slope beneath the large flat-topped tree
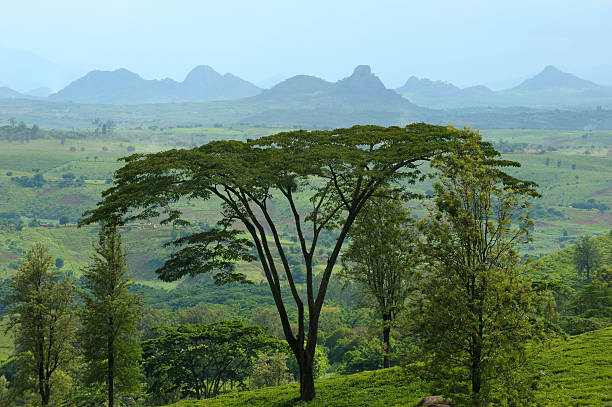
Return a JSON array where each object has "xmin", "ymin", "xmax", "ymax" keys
[{"xmin": 163, "ymin": 328, "xmax": 612, "ymax": 407}]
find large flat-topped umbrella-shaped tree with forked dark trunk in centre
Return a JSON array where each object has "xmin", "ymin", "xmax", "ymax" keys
[{"xmin": 82, "ymin": 123, "xmax": 474, "ymax": 400}]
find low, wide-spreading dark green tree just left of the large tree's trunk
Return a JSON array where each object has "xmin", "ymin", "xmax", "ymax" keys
[{"xmin": 143, "ymin": 321, "xmax": 282, "ymax": 399}]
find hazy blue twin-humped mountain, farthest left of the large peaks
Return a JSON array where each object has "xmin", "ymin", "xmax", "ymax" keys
[{"xmin": 49, "ymin": 66, "xmax": 260, "ymax": 104}]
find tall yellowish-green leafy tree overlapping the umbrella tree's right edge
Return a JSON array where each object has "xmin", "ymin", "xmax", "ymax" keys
[{"xmin": 406, "ymin": 135, "xmax": 537, "ymax": 405}]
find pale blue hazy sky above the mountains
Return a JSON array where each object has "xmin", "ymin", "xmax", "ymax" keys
[{"xmin": 0, "ymin": 0, "xmax": 612, "ymax": 88}]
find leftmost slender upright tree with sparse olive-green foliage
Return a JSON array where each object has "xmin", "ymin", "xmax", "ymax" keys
[{"xmin": 6, "ymin": 243, "xmax": 75, "ymax": 406}]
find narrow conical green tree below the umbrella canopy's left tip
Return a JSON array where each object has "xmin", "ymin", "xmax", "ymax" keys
[{"xmin": 79, "ymin": 225, "xmax": 141, "ymax": 407}]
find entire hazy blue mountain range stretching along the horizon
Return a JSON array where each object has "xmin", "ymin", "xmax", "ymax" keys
[{"xmin": 0, "ymin": 65, "xmax": 612, "ymax": 109}]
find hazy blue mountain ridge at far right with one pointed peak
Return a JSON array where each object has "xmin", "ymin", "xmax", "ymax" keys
[{"xmin": 395, "ymin": 65, "xmax": 612, "ymax": 108}]
